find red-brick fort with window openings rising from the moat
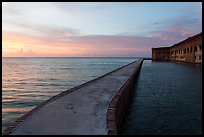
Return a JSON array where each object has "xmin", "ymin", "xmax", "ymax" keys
[{"xmin": 152, "ymin": 32, "xmax": 202, "ymax": 64}]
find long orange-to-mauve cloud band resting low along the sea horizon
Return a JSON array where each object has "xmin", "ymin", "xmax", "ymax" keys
[{"xmin": 3, "ymin": 32, "xmax": 164, "ymax": 56}]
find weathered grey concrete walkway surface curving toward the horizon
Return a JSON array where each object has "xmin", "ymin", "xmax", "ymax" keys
[{"xmin": 4, "ymin": 61, "xmax": 141, "ymax": 135}]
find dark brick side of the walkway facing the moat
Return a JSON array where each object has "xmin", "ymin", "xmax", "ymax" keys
[{"xmin": 107, "ymin": 60, "xmax": 143, "ymax": 135}]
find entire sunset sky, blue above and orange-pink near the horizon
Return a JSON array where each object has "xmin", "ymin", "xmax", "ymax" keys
[{"xmin": 2, "ymin": 2, "xmax": 202, "ymax": 57}]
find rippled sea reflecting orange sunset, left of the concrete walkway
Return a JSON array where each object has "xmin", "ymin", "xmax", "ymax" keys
[{"xmin": 2, "ymin": 58, "xmax": 138, "ymax": 131}]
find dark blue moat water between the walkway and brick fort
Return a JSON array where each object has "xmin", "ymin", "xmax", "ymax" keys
[{"xmin": 121, "ymin": 61, "xmax": 202, "ymax": 135}]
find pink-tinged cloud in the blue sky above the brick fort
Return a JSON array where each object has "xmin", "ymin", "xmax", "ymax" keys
[{"xmin": 150, "ymin": 13, "xmax": 202, "ymax": 43}]
